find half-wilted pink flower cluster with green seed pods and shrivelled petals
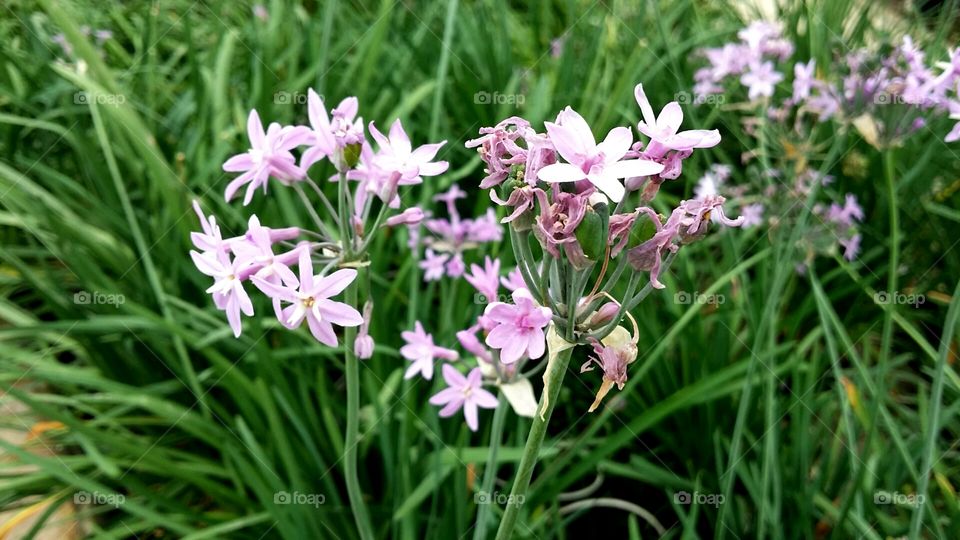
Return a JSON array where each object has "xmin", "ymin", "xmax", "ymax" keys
[{"xmin": 458, "ymin": 84, "xmax": 743, "ymax": 416}]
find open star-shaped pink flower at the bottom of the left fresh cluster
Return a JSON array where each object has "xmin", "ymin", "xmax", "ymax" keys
[{"xmin": 251, "ymin": 250, "xmax": 363, "ymax": 347}]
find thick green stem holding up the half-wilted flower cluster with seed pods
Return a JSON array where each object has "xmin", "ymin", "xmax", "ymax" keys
[{"xmin": 497, "ymin": 347, "xmax": 573, "ymax": 540}]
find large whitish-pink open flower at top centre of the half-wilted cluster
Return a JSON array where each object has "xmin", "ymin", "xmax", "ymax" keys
[{"xmin": 537, "ymin": 107, "xmax": 663, "ymax": 202}]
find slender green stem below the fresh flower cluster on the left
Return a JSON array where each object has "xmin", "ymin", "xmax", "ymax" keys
[{"xmin": 343, "ymin": 285, "xmax": 373, "ymax": 540}]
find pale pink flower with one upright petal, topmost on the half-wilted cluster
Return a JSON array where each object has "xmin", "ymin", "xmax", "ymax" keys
[{"xmin": 633, "ymin": 84, "xmax": 720, "ymax": 154}]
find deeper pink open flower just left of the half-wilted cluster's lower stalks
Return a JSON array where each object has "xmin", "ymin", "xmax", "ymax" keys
[{"xmin": 483, "ymin": 289, "xmax": 551, "ymax": 364}]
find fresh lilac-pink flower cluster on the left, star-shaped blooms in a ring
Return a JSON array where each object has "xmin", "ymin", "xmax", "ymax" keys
[{"xmin": 190, "ymin": 89, "xmax": 447, "ymax": 350}]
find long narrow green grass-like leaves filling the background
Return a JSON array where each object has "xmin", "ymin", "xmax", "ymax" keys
[{"xmin": 0, "ymin": 0, "xmax": 960, "ymax": 539}]
